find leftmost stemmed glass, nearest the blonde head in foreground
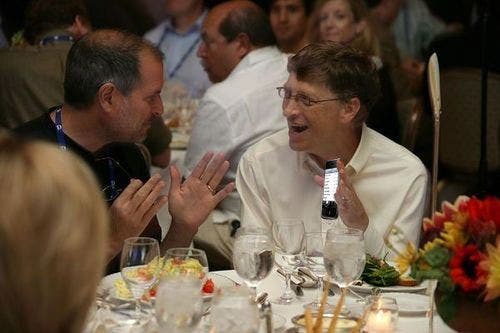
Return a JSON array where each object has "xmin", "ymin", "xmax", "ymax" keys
[{"xmin": 120, "ymin": 237, "xmax": 160, "ymax": 322}]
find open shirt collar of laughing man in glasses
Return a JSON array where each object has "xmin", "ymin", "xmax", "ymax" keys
[{"xmin": 296, "ymin": 124, "xmax": 370, "ymax": 176}]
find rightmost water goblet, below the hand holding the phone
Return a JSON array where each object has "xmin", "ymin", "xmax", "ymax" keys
[{"xmin": 324, "ymin": 228, "xmax": 366, "ymax": 293}]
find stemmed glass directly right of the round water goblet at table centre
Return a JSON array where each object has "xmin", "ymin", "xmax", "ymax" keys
[{"xmin": 273, "ymin": 219, "xmax": 305, "ymax": 304}]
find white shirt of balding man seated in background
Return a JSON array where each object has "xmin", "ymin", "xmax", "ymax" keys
[{"xmin": 184, "ymin": 46, "xmax": 288, "ymax": 223}]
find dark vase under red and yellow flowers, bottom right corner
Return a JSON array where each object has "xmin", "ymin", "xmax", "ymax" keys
[{"xmin": 435, "ymin": 290, "xmax": 500, "ymax": 333}]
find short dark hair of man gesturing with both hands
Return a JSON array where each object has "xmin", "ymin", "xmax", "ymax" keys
[{"xmin": 64, "ymin": 30, "xmax": 163, "ymax": 108}]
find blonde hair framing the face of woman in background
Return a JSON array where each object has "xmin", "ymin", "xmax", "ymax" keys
[{"xmin": 309, "ymin": 0, "xmax": 380, "ymax": 57}]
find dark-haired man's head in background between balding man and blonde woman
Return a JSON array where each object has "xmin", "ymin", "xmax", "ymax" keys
[{"xmin": 268, "ymin": 0, "xmax": 313, "ymax": 53}]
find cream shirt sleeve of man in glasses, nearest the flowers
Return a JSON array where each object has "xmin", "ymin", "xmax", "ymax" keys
[{"xmin": 365, "ymin": 166, "xmax": 429, "ymax": 258}]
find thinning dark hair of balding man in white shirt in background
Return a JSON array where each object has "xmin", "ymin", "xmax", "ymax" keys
[{"xmin": 219, "ymin": 4, "xmax": 276, "ymax": 47}]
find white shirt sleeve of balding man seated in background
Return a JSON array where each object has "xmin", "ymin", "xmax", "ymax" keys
[{"xmin": 183, "ymin": 99, "xmax": 234, "ymax": 176}]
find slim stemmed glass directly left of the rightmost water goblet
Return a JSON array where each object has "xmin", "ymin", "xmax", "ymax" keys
[{"xmin": 304, "ymin": 232, "xmax": 330, "ymax": 310}]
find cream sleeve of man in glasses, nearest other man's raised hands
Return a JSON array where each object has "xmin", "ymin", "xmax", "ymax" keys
[{"xmin": 236, "ymin": 154, "xmax": 272, "ymax": 230}]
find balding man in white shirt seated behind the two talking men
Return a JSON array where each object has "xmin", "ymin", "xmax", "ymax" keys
[{"xmin": 184, "ymin": 1, "xmax": 287, "ymax": 269}]
